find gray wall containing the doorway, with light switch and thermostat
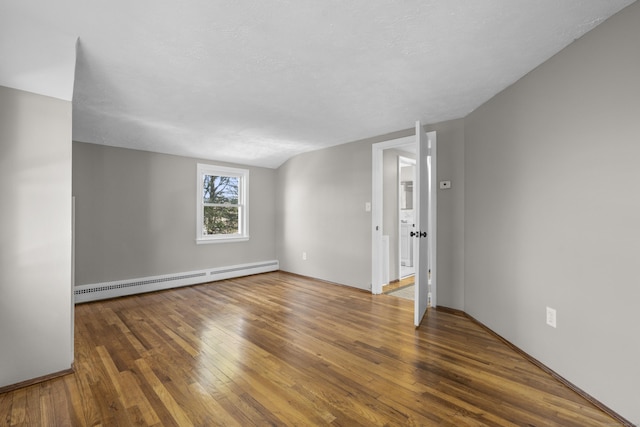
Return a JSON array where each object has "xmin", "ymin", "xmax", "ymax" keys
[{"xmin": 276, "ymin": 124, "xmax": 464, "ymax": 310}]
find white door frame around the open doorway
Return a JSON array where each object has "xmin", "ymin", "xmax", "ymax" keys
[{"xmin": 371, "ymin": 131, "xmax": 437, "ymax": 307}]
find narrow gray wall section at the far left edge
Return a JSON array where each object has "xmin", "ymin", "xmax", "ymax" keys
[{"xmin": 0, "ymin": 86, "xmax": 73, "ymax": 387}]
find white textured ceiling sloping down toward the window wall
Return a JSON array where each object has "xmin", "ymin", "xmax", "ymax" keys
[{"xmin": 0, "ymin": 0, "xmax": 633, "ymax": 167}]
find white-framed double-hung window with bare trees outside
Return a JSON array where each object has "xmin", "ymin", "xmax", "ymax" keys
[{"xmin": 196, "ymin": 163, "xmax": 249, "ymax": 243}]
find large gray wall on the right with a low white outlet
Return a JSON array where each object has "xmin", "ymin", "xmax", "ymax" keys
[{"xmin": 464, "ymin": 3, "xmax": 640, "ymax": 423}]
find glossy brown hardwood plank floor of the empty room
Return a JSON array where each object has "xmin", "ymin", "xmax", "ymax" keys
[{"xmin": 0, "ymin": 272, "xmax": 620, "ymax": 427}]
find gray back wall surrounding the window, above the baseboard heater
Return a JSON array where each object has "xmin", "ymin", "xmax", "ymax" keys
[{"xmin": 73, "ymin": 142, "xmax": 276, "ymax": 285}]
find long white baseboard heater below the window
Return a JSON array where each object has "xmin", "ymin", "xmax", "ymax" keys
[{"xmin": 73, "ymin": 261, "xmax": 280, "ymax": 304}]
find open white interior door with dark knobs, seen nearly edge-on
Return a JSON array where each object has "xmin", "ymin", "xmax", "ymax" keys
[{"xmin": 413, "ymin": 122, "xmax": 429, "ymax": 327}]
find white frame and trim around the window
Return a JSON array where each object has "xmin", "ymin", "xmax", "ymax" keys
[{"xmin": 196, "ymin": 163, "xmax": 249, "ymax": 244}]
